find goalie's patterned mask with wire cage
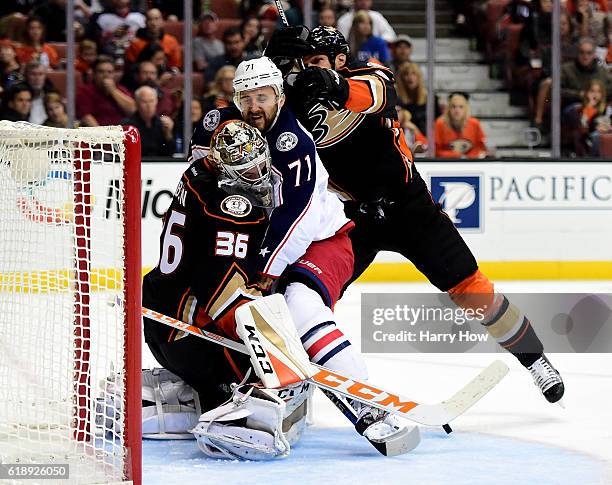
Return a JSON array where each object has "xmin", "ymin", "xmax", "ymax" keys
[{"xmin": 208, "ymin": 120, "xmax": 275, "ymax": 207}]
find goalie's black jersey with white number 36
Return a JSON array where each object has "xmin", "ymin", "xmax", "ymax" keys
[{"xmin": 143, "ymin": 160, "xmax": 268, "ymax": 342}]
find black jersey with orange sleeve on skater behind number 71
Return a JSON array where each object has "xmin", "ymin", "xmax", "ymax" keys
[{"xmin": 286, "ymin": 60, "xmax": 412, "ymax": 201}]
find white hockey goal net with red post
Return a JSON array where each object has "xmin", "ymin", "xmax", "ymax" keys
[{"xmin": 0, "ymin": 121, "xmax": 142, "ymax": 485}]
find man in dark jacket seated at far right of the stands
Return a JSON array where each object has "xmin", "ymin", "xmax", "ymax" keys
[{"xmin": 561, "ymin": 37, "xmax": 612, "ymax": 108}]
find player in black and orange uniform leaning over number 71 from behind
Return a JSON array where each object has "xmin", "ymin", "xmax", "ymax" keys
[{"xmin": 266, "ymin": 26, "xmax": 564, "ymax": 402}]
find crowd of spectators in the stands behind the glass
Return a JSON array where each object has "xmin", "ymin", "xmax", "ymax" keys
[{"xmin": 0, "ymin": 0, "xmax": 612, "ymax": 158}]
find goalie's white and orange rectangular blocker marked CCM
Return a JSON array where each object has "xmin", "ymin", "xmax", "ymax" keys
[{"xmin": 236, "ymin": 294, "xmax": 316, "ymax": 389}]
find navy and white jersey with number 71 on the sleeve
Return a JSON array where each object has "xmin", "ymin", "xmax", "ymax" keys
[{"xmin": 189, "ymin": 107, "xmax": 349, "ymax": 278}]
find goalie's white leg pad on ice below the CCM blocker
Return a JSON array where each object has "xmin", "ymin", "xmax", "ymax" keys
[{"xmin": 193, "ymin": 383, "xmax": 314, "ymax": 460}]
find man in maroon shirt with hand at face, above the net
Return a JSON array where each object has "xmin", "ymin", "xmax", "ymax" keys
[{"xmin": 76, "ymin": 56, "xmax": 136, "ymax": 126}]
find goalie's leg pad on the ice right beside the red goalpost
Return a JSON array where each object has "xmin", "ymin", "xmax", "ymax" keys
[{"xmin": 142, "ymin": 368, "xmax": 202, "ymax": 439}]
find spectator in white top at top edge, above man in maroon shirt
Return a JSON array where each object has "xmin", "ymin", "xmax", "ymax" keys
[{"xmin": 88, "ymin": 0, "xmax": 146, "ymax": 65}]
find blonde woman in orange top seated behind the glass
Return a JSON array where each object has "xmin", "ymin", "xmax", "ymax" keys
[{"xmin": 435, "ymin": 92, "xmax": 487, "ymax": 158}]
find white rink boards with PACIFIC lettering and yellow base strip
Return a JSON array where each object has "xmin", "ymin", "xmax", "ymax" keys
[{"xmin": 137, "ymin": 160, "xmax": 612, "ymax": 282}]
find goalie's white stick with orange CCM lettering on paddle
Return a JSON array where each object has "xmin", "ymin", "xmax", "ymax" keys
[{"xmin": 142, "ymin": 307, "xmax": 508, "ymax": 426}]
